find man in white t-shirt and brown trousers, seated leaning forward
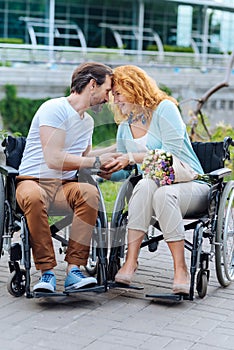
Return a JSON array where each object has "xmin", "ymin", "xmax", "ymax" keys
[{"xmin": 16, "ymin": 62, "xmax": 118, "ymax": 293}]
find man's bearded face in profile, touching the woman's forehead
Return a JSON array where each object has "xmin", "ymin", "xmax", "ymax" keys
[{"xmin": 90, "ymin": 75, "xmax": 112, "ymax": 110}]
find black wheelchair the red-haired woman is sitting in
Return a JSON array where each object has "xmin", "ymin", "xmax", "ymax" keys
[{"xmin": 108, "ymin": 137, "xmax": 234, "ymax": 301}]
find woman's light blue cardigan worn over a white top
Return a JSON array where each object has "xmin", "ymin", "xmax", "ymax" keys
[{"xmin": 111, "ymin": 100, "xmax": 203, "ymax": 181}]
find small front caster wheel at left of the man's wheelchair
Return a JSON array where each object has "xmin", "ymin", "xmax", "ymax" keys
[{"xmin": 7, "ymin": 269, "xmax": 26, "ymax": 297}]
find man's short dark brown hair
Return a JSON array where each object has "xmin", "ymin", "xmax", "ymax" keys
[{"xmin": 71, "ymin": 62, "xmax": 113, "ymax": 94}]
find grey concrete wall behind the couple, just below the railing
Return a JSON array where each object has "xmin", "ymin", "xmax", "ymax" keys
[{"xmin": 0, "ymin": 65, "xmax": 234, "ymax": 126}]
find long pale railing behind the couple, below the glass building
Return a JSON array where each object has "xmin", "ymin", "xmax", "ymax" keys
[{"xmin": 0, "ymin": 43, "xmax": 230, "ymax": 70}]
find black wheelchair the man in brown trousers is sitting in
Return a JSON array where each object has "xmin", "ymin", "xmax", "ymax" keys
[{"xmin": 0, "ymin": 136, "xmax": 108, "ymax": 298}]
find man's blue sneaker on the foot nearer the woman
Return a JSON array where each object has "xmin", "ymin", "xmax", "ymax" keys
[{"xmin": 64, "ymin": 267, "xmax": 97, "ymax": 291}]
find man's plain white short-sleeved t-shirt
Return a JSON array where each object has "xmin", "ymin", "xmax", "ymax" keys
[{"xmin": 19, "ymin": 97, "xmax": 94, "ymax": 179}]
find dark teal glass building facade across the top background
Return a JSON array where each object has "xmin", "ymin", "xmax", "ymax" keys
[{"xmin": 0, "ymin": 0, "xmax": 234, "ymax": 53}]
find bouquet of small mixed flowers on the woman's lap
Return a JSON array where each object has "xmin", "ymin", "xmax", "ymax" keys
[{"xmin": 141, "ymin": 149, "xmax": 175, "ymax": 186}]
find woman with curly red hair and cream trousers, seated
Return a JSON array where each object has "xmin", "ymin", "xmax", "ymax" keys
[{"xmin": 107, "ymin": 65, "xmax": 209, "ymax": 294}]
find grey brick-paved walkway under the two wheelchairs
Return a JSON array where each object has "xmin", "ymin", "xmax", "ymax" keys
[{"xmin": 0, "ymin": 235, "xmax": 234, "ymax": 350}]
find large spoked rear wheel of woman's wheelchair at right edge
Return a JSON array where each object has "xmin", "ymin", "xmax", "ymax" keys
[{"xmin": 215, "ymin": 181, "xmax": 234, "ymax": 287}]
